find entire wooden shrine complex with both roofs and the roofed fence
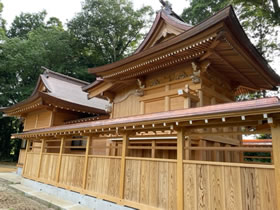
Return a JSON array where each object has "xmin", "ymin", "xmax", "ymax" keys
[{"xmin": 3, "ymin": 6, "xmax": 280, "ymax": 210}]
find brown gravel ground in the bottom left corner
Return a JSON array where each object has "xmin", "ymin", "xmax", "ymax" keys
[{"xmin": 0, "ymin": 179, "xmax": 53, "ymax": 210}]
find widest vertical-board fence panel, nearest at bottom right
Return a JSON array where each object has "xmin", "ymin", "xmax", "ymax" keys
[{"xmin": 184, "ymin": 163, "xmax": 277, "ymax": 210}]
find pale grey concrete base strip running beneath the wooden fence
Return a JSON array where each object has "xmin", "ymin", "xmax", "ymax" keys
[{"xmin": 21, "ymin": 178, "xmax": 133, "ymax": 210}]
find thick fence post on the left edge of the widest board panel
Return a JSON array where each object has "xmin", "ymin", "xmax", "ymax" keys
[{"xmin": 177, "ymin": 128, "xmax": 185, "ymax": 210}]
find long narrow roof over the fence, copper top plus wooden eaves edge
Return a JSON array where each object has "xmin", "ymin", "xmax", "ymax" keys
[{"xmin": 13, "ymin": 97, "xmax": 280, "ymax": 136}]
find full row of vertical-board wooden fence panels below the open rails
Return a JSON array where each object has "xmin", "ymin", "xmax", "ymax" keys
[{"xmin": 23, "ymin": 149, "xmax": 276, "ymax": 210}]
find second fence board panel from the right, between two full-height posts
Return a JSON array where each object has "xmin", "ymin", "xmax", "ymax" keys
[{"xmin": 124, "ymin": 159, "xmax": 177, "ymax": 210}]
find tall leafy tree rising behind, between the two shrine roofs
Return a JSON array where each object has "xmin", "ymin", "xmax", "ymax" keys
[{"xmin": 68, "ymin": 0, "xmax": 152, "ymax": 66}]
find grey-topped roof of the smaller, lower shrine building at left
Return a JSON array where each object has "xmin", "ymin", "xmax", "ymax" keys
[{"xmin": 1, "ymin": 69, "xmax": 108, "ymax": 113}]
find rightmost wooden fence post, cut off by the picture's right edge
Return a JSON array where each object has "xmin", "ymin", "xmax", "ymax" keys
[{"xmin": 271, "ymin": 124, "xmax": 280, "ymax": 209}]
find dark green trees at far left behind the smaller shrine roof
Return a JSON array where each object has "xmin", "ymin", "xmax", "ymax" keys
[{"xmin": 0, "ymin": 21, "xmax": 91, "ymax": 159}]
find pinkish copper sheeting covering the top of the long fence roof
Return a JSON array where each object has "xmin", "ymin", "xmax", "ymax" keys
[{"xmin": 14, "ymin": 97, "xmax": 280, "ymax": 135}]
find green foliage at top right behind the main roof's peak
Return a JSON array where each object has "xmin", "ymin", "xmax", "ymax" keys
[{"xmin": 182, "ymin": 0, "xmax": 280, "ymax": 61}]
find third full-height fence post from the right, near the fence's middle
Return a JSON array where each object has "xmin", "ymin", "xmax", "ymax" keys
[{"xmin": 120, "ymin": 133, "xmax": 129, "ymax": 199}]
